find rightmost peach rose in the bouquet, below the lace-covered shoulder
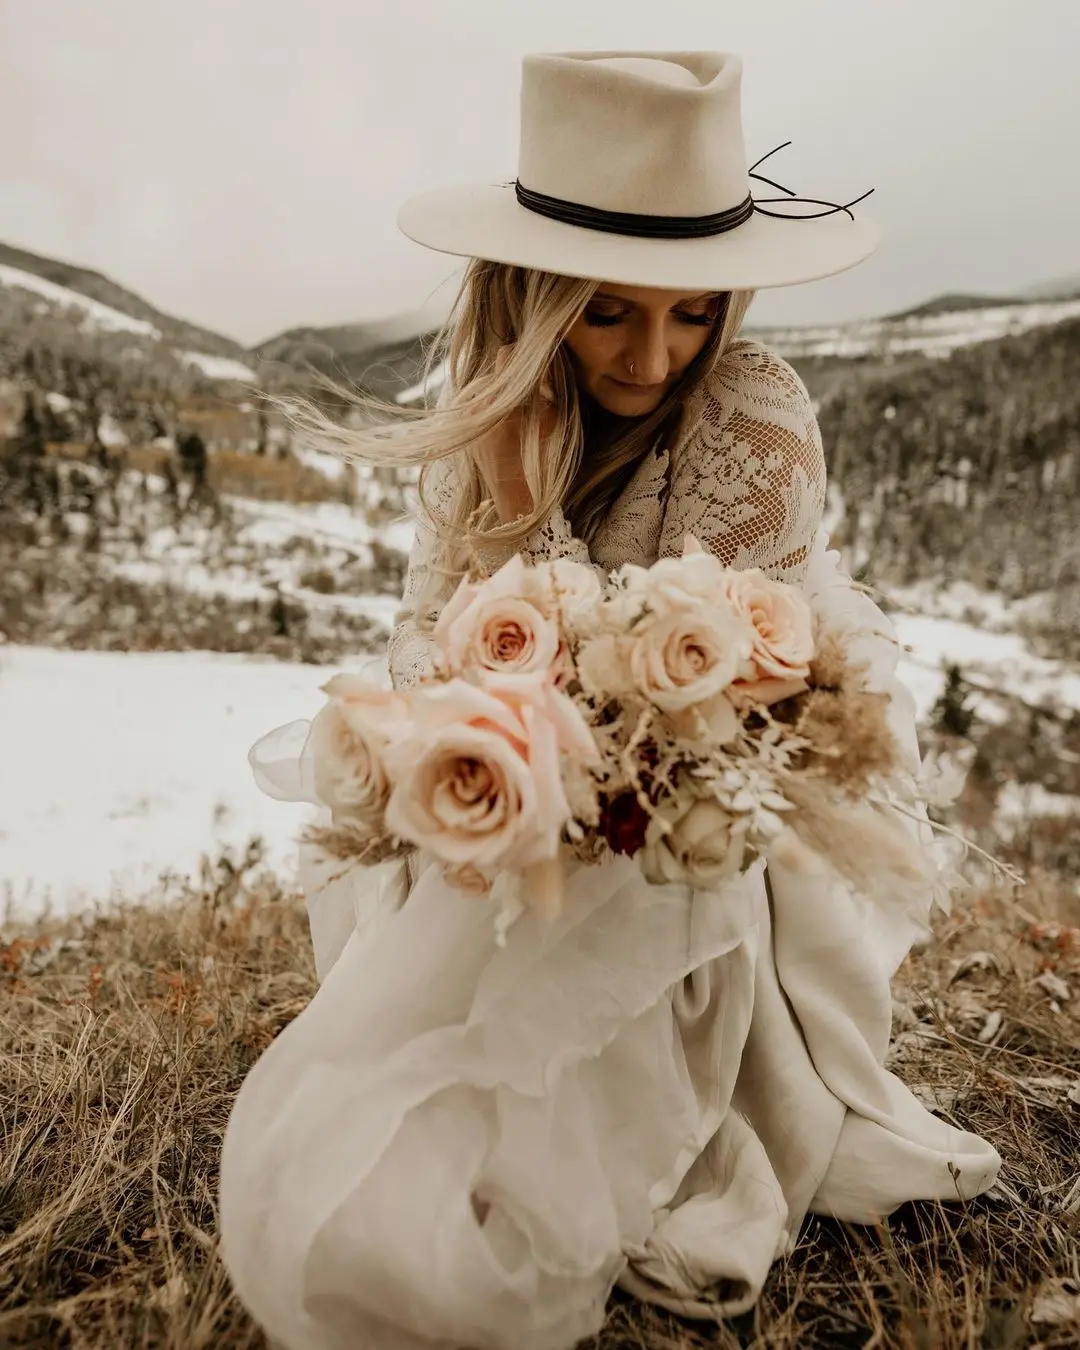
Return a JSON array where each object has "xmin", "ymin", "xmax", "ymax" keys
[{"xmin": 724, "ymin": 567, "xmax": 814, "ymax": 703}]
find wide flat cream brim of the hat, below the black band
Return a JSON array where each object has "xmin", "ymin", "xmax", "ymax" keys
[{"xmin": 397, "ymin": 182, "xmax": 882, "ymax": 290}]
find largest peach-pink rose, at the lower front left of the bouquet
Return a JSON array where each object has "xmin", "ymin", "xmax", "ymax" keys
[{"xmin": 386, "ymin": 676, "xmax": 570, "ymax": 868}]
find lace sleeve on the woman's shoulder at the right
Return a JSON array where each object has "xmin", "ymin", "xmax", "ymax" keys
[{"xmin": 659, "ymin": 340, "xmax": 825, "ymax": 583}]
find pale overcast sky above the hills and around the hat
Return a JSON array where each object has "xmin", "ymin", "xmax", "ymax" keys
[{"xmin": 0, "ymin": 0, "xmax": 1080, "ymax": 343}]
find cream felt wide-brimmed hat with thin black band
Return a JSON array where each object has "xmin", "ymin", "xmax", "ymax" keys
[{"xmin": 397, "ymin": 51, "xmax": 880, "ymax": 290}]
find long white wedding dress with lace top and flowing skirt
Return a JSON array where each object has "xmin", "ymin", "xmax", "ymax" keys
[{"xmin": 220, "ymin": 342, "xmax": 1000, "ymax": 1350}]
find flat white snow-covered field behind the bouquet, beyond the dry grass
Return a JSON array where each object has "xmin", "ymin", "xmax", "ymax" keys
[{"xmin": 0, "ymin": 597, "xmax": 1080, "ymax": 913}]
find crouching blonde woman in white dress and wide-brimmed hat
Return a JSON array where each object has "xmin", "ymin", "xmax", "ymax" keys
[{"xmin": 220, "ymin": 53, "xmax": 1000, "ymax": 1350}]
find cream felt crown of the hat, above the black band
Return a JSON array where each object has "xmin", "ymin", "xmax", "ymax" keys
[{"xmin": 518, "ymin": 51, "xmax": 749, "ymax": 217}]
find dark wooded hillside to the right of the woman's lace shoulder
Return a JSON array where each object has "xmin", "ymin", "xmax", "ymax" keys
[{"xmin": 797, "ymin": 317, "xmax": 1080, "ymax": 655}]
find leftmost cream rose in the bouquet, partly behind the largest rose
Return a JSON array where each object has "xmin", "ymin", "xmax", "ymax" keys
[{"xmin": 308, "ymin": 675, "xmax": 410, "ymax": 833}]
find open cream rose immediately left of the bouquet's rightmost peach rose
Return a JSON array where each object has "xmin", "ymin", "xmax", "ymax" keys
[{"xmin": 630, "ymin": 605, "xmax": 752, "ymax": 713}]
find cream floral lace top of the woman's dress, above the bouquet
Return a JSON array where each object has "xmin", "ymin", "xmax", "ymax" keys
[{"xmin": 387, "ymin": 339, "xmax": 825, "ymax": 689}]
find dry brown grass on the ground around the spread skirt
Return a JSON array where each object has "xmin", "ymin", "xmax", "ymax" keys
[{"xmin": 0, "ymin": 848, "xmax": 1080, "ymax": 1350}]
